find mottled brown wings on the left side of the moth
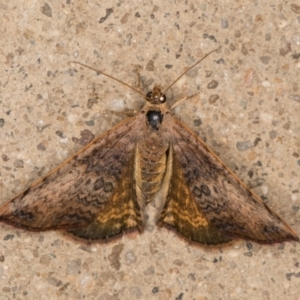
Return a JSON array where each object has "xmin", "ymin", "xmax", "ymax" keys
[{"xmin": 0, "ymin": 118, "xmax": 142, "ymax": 238}]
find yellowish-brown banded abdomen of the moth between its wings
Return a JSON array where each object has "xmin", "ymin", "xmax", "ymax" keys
[{"xmin": 136, "ymin": 135, "xmax": 169, "ymax": 203}]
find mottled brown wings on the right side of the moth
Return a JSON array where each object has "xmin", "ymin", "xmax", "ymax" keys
[{"xmin": 162, "ymin": 118, "xmax": 299, "ymax": 244}]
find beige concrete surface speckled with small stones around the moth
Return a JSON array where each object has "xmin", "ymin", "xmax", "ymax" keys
[{"xmin": 0, "ymin": 0, "xmax": 300, "ymax": 300}]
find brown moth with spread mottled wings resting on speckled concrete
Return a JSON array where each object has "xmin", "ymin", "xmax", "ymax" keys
[{"xmin": 0, "ymin": 50, "xmax": 299, "ymax": 244}]
